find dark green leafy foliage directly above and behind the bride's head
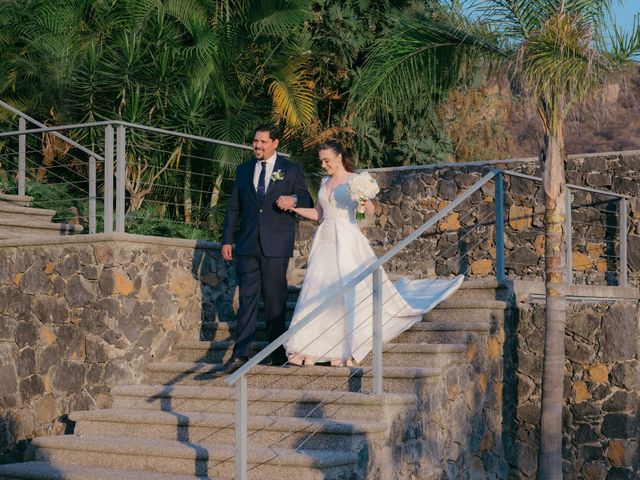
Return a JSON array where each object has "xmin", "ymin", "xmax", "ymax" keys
[{"xmin": 301, "ymin": 0, "xmax": 458, "ymax": 168}]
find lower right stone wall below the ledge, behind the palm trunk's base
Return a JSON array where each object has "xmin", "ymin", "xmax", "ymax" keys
[{"xmin": 503, "ymin": 301, "xmax": 640, "ymax": 480}]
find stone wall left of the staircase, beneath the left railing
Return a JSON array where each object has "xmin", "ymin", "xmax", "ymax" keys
[{"xmin": 0, "ymin": 235, "xmax": 234, "ymax": 463}]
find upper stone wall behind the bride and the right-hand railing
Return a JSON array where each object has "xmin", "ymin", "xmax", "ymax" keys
[{"xmin": 292, "ymin": 152, "xmax": 640, "ymax": 286}]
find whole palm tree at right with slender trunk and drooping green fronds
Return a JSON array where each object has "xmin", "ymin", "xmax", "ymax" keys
[{"xmin": 352, "ymin": 0, "xmax": 640, "ymax": 479}]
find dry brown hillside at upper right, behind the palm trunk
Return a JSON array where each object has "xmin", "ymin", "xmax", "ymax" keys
[{"xmin": 438, "ymin": 65, "xmax": 640, "ymax": 162}]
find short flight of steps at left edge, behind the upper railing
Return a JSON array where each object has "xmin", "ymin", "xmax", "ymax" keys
[{"xmin": 0, "ymin": 193, "xmax": 82, "ymax": 240}]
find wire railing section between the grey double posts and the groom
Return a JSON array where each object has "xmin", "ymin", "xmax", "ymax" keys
[{"xmin": 120, "ymin": 124, "xmax": 240, "ymax": 239}]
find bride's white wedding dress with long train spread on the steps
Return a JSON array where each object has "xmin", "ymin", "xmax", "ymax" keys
[{"xmin": 285, "ymin": 177, "xmax": 464, "ymax": 362}]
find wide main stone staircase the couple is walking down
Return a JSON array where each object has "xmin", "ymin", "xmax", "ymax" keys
[{"xmin": 0, "ymin": 281, "xmax": 506, "ymax": 480}]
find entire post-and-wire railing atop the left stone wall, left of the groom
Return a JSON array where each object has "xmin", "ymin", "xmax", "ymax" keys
[{"xmin": 0, "ymin": 114, "xmax": 250, "ymax": 240}]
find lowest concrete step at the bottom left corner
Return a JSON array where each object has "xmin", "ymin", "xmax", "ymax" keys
[{"xmin": 0, "ymin": 461, "xmax": 210, "ymax": 480}]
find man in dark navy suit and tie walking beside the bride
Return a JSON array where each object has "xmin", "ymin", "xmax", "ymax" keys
[{"xmin": 222, "ymin": 125, "xmax": 312, "ymax": 374}]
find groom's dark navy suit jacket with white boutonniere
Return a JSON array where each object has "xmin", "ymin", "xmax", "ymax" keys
[{"xmin": 222, "ymin": 155, "xmax": 313, "ymax": 257}]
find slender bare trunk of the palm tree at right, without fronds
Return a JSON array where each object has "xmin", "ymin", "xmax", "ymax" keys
[{"xmin": 537, "ymin": 118, "xmax": 570, "ymax": 480}]
